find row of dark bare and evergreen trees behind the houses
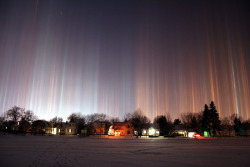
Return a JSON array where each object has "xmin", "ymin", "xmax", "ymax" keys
[{"xmin": 0, "ymin": 101, "xmax": 250, "ymax": 136}]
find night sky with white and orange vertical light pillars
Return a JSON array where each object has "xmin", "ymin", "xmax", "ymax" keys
[{"xmin": 0, "ymin": 0, "xmax": 250, "ymax": 121}]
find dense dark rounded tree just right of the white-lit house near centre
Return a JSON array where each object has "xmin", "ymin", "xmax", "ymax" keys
[{"xmin": 154, "ymin": 114, "xmax": 172, "ymax": 136}]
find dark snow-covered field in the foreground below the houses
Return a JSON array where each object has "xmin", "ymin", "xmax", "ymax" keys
[{"xmin": 0, "ymin": 135, "xmax": 250, "ymax": 167}]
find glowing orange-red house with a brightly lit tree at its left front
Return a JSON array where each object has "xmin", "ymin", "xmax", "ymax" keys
[{"xmin": 108, "ymin": 122, "xmax": 134, "ymax": 136}]
